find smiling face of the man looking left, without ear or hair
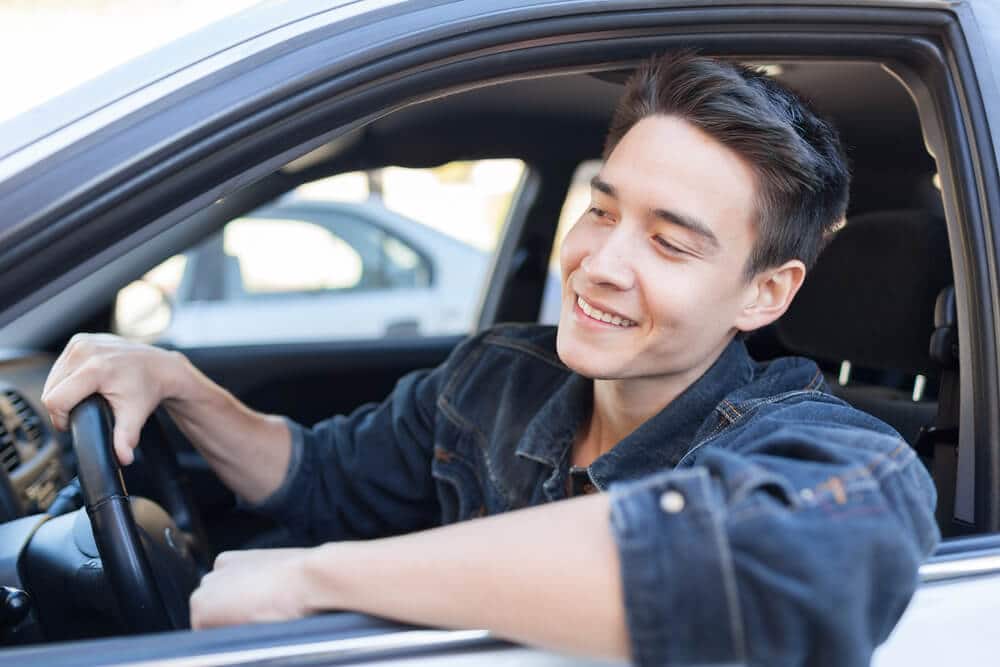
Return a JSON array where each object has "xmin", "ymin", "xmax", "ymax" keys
[{"xmin": 558, "ymin": 116, "xmax": 756, "ymax": 382}]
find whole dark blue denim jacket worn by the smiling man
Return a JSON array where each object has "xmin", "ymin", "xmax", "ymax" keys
[{"xmin": 260, "ymin": 325, "xmax": 939, "ymax": 667}]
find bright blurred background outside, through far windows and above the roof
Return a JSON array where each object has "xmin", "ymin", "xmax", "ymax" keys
[{"xmin": 0, "ymin": 0, "xmax": 599, "ymax": 344}]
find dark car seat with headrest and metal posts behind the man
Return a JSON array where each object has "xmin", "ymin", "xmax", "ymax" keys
[{"xmin": 775, "ymin": 210, "xmax": 953, "ymax": 445}]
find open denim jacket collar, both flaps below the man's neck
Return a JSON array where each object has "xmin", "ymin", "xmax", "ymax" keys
[{"xmin": 517, "ymin": 337, "xmax": 754, "ymax": 489}]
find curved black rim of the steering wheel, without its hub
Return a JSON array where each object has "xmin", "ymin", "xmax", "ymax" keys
[{"xmin": 70, "ymin": 395, "xmax": 173, "ymax": 632}]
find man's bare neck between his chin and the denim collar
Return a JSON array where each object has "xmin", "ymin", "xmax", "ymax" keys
[{"xmin": 572, "ymin": 340, "xmax": 729, "ymax": 467}]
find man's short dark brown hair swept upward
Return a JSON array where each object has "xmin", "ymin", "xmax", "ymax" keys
[{"xmin": 604, "ymin": 51, "xmax": 850, "ymax": 280}]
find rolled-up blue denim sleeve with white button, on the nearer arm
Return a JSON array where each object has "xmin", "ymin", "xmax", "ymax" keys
[{"xmin": 611, "ymin": 405, "xmax": 940, "ymax": 667}]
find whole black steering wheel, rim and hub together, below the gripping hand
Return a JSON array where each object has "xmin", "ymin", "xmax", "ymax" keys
[{"xmin": 70, "ymin": 394, "xmax": 198, "ymax": 633}]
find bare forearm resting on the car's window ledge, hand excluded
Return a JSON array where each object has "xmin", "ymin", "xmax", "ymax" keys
[{"xmin": 304, "ymin": 494, "xmax": 628, "ymax": 658}]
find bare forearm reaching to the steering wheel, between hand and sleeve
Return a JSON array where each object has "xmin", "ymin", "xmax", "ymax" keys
[{"xmin": 163, "ymin": 357, "xmax": 291, "ymax": 502}]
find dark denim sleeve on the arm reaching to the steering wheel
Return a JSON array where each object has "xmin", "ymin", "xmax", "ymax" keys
[{"xmin": 249, "ymin": 336, "xmax": 480, "ymax": 544}]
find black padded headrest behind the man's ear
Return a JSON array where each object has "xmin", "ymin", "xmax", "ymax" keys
[{"xmin": 776, "ymin": 210, "xmax": 953, "ymax": 374}]
